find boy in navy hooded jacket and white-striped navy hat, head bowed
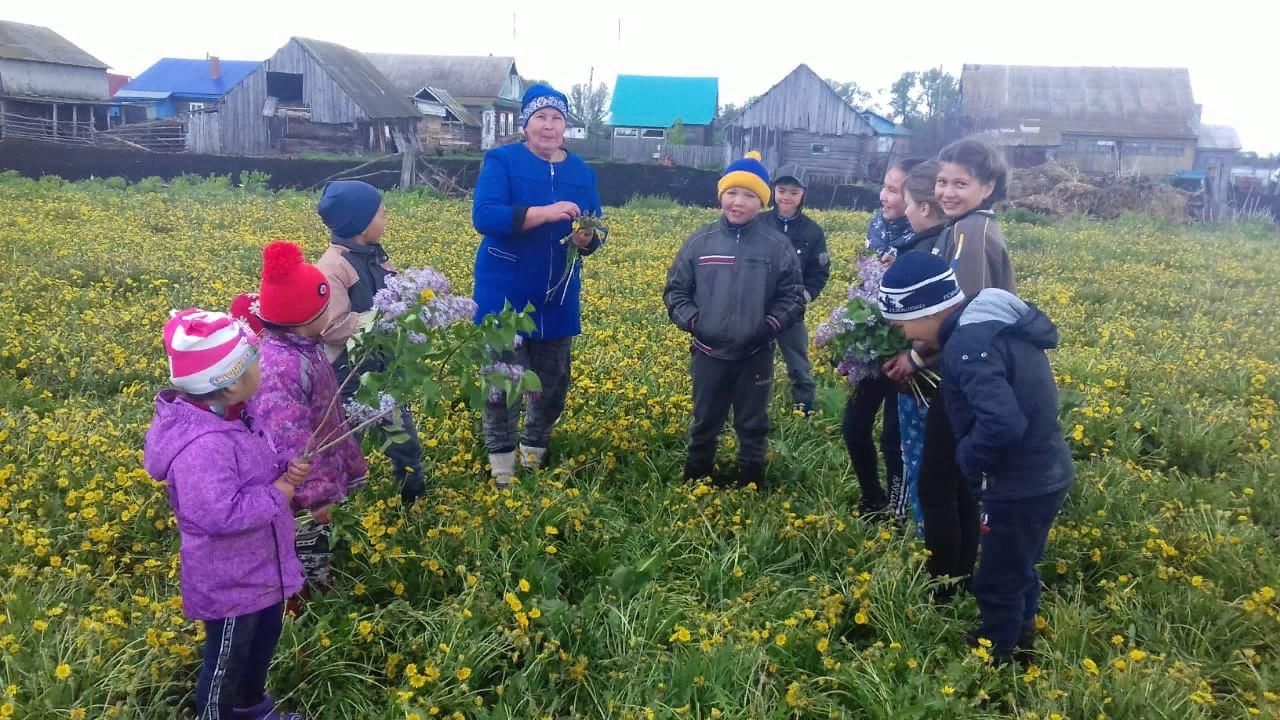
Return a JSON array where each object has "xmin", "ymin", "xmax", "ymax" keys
[{"xmin": 879, "ymin": 252, "xmax": 1075, "ymax": 660}]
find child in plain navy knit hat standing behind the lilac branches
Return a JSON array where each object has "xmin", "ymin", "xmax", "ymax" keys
[{"xmin": 316, "ymin": 181, "xmax": 426, "ymax": 506}]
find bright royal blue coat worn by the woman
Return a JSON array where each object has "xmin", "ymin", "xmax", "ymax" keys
[{"xmin": 471, "ymin": 143, "xmax": 602, "ymax": 340}]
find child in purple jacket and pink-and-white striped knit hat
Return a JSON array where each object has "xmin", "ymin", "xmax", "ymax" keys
[{"xmin": 143, "ymin": 309, "xmax": 310, "ymax": 720}]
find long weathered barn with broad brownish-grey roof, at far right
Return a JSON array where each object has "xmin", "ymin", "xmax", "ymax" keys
[{"xmin": 960, "ymin": 65, "xmax": 1199, "ymax": 176}]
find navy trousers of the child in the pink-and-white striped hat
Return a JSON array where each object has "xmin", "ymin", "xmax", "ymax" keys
[{"xmin": 196, "ymin": 602, "xmax": 284, "ymax": 720}]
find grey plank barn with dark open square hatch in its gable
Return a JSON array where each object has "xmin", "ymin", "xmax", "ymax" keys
[{"xmin": 188, "ymin": 37, "xmax": 422, "ymax": 155}]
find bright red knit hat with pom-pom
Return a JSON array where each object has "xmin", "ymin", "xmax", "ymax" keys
[{"xmin": 257, "ymin": 241, "xmax": 329, "ymax": 327}]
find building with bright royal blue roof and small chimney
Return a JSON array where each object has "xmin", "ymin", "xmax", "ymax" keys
[{"xmin": 115, "ymin": 58, "xmax": 262, "ymax": 123}]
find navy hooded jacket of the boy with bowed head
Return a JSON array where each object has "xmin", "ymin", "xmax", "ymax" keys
[{"xmin": 940, "ymin": 288, "xmax": 1075, "ymax": 500}]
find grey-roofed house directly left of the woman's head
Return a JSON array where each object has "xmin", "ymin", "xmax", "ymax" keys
[{"xmin": 367, "ymin": 53, "xmax": 525, "ymax": 150}]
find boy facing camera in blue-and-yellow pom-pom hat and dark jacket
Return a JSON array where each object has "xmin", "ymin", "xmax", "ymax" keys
[{"xmin": 663, "ymin": 152, "xmax": 804, "ymax": 486}]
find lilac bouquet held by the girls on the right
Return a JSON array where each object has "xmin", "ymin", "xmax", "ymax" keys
[{"xmin": 814, "ymin": 256, "xmax": 937, "ymax": 402}]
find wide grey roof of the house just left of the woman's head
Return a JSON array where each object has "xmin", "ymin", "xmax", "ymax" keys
[{"xmin": 366, "ymin": 53, "xmax": 516, "ymax": 105}]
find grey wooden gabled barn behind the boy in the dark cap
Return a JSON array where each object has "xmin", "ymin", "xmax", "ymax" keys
[{"xmin": 724, "ymin": 65, "xmax": 875, "ymax": 184}]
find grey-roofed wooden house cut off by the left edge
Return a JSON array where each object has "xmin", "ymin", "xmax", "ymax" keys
[{"xmin": 0, "ymin": 20, "xmax": 110, "ymax": 141}]
